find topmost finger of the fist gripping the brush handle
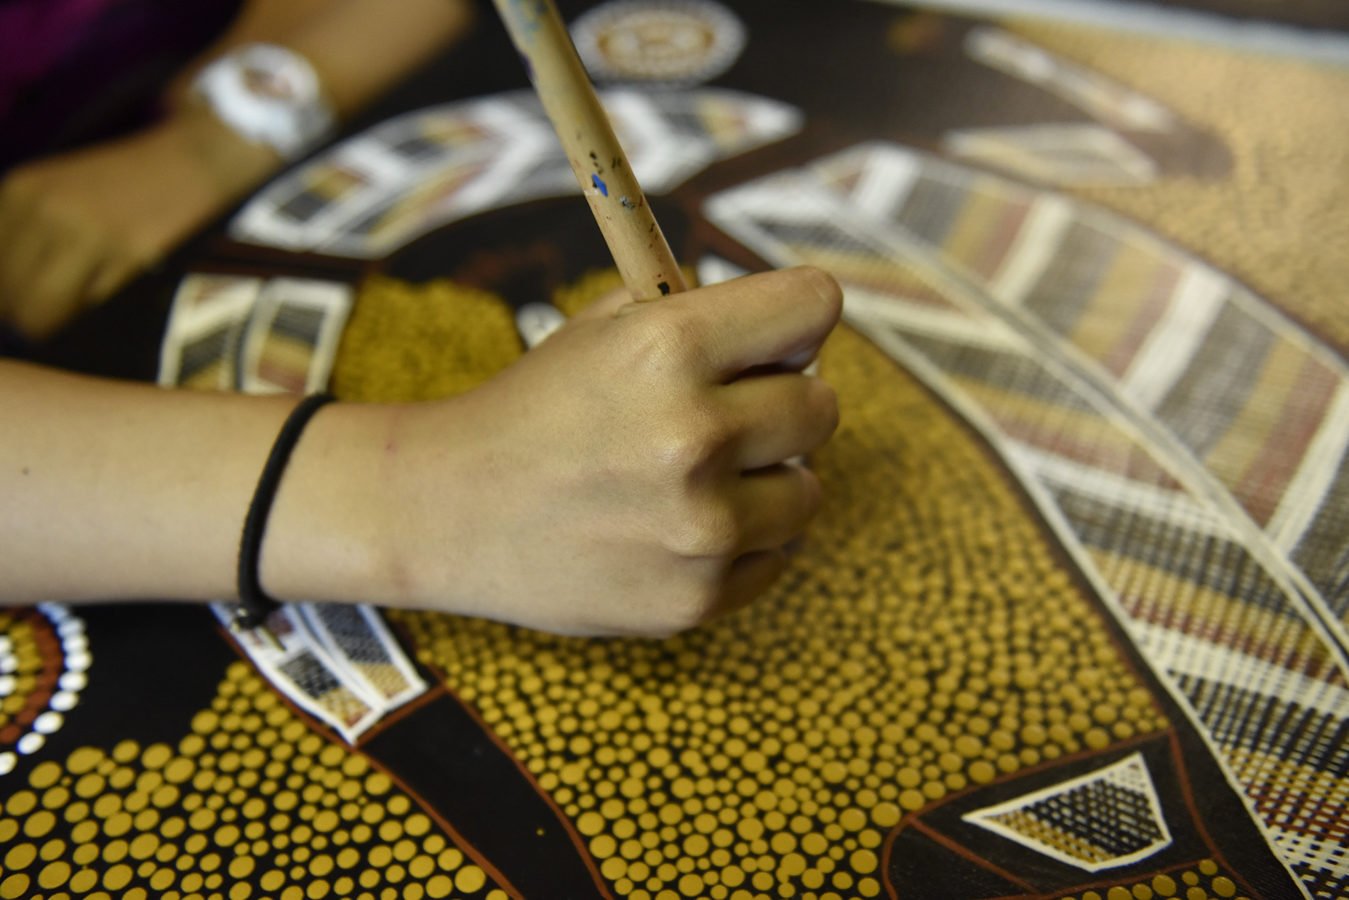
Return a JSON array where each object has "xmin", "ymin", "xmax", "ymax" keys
[{"xmin": 669, "ymin": 266, "xmax": 843, "ymax": 381}]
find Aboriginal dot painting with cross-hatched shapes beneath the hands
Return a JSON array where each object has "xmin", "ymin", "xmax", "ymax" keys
[{"xmin": 0, "ymin": 0, "xmax": 1349, "ymax": 900}]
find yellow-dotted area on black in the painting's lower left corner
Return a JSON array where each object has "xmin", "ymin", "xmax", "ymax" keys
[{"xmin": 0, "ymin": 663, "xmax": 506, "ymax": 900}]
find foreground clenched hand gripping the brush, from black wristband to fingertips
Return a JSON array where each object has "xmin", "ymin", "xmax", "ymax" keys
[{"xmin": 262, "ymin": 269, "xmax": 842, "ymax": 637}]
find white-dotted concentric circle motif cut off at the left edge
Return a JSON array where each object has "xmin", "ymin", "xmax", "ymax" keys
[{"xmin": 0, "ymin": 603, "xmax": 92, "ymax": 776}]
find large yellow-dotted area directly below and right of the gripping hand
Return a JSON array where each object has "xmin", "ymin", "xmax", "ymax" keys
[{"xmin": 375, "ymin": 274, "xmax": 1166, "ymax": 900}]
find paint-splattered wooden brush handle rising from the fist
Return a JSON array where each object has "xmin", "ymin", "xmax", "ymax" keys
[{"xmin": 494, "ymin": 0, "xmax": 684, "ymax": 300}]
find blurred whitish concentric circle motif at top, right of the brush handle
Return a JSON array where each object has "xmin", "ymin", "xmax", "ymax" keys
[{"xmin": 571, "ymin": 0, "xmax": 746, "ymax": 85}]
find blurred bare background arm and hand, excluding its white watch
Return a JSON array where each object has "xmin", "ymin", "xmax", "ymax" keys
[{"xmin": 0, "ymin": 0, "xmax": 471, "ymax": 340}]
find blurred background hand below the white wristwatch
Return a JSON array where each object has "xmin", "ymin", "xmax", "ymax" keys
[{"xmin": 0, "ymin": 109, "xmax": 279, "ymax": 340}]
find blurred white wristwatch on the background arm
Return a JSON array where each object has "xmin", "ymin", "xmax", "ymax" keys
[{"xmin": 193, "ymin": 43, "xmax": 335, "ymax": 159}]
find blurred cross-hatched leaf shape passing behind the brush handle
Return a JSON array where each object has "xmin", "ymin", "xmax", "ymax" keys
[{"xmin": 231, "ymin": 88, "xmax": 801, "ymax": 259}]
